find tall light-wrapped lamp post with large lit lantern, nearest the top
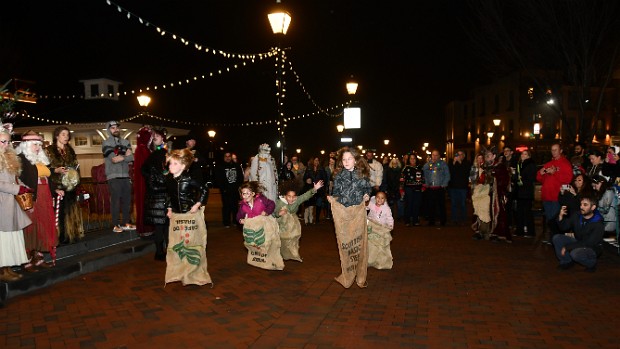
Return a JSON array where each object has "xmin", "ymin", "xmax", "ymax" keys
[{"xmin": 267, "ymin": 6, "xmax": 291, "ymax": 163}]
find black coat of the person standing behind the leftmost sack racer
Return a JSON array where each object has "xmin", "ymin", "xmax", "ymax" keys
[{"xmin": 141, "ymin": 149, "xmax": 168, "ymax": 225}]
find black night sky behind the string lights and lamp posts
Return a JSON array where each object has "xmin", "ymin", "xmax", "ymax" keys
[{"xmin": 0, "ymin": 0, "xmax": 485, "ymax": 160}]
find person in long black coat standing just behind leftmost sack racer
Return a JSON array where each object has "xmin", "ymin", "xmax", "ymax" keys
[{"xmin": 142, "ymin": 129, "xmax": 168, "ymax": 261}]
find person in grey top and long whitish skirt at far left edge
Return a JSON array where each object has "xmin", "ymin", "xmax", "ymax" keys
[{"xmin": 0, "ymin": 124, "xmax": 32, "ymax": 282}]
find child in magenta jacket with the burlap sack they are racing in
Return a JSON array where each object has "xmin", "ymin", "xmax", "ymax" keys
[{"xmin": 237, "ymin": 182, "xmax": 284, "ymax": 270}]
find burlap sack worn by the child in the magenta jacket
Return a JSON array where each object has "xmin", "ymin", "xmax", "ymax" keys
[{"xmin": 243, "ymin": 216, "xmax": 284, "ymax": 270}]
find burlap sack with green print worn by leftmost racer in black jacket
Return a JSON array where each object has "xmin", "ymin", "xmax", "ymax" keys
[{"xmin": 166, "ymin": 207, "xmax": 213, "ymax": 286}]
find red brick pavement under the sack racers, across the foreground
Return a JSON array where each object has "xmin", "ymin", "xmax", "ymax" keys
[{"xmin": 0, "ymin": 193, "xmax": 620, "ymax": 349}]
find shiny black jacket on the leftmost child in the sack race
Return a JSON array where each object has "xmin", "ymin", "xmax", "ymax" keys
[{"xmin": 166, "ymin": 171, "xmax": 209, "ymax": 213}]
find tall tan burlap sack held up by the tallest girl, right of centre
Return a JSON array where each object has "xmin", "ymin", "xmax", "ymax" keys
[{"xmin": 331, "ymin": 200, "xmax": 368, "ymax": 288}]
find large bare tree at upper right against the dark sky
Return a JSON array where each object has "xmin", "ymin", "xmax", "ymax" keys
[{"xmin": 463, "ymin": 0, "xmax": 620, "ymax": 140}]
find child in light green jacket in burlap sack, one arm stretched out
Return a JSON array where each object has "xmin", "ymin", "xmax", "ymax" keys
[{"xmin": 273, "ymin": 180, "xmax": 323, "ymax": 262}]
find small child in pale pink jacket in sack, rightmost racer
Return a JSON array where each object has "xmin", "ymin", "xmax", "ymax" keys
[{"xmin": 366, "ymin": 191, "xmax": 394, "ymax": 269}]
